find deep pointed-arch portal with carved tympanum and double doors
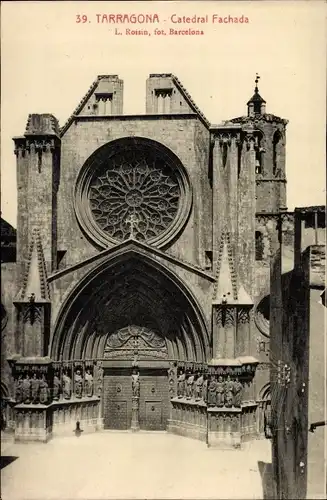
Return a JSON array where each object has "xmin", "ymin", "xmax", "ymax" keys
[{"xmin": 51, "ymin": 252, "xmax": 209, "ymax": 429}]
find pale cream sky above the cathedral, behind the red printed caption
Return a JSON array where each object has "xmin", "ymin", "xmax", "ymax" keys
[{"xmin": 1, "ymin": 0, "xmax": 326, "ymax": 226}]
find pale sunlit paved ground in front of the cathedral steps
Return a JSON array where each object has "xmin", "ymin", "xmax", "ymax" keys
[{"xmin": 1, "ymin": 432, "xmax": 271, "ymax": 500}]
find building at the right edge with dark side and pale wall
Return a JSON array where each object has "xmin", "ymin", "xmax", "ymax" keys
[{"xmin": 267, "ymin": 206, "xmax": 326, "ymax": 498}]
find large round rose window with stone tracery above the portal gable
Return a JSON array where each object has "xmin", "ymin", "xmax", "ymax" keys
[{"xmin": 76, "ymin": 139, "xmax": 191, "ymax": 245}]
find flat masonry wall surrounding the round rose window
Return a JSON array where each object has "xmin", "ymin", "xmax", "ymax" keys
[{"xmin": 58, "ymin": 117, "xmax": 210, "ymax": 266}]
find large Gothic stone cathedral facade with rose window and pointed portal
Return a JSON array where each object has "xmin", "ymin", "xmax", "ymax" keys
[{"xmin": 1, "ymin": 74, "xmax": 293, "ymax": 448}]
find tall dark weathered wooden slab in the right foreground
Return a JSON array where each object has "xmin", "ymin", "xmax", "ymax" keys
[{"xmin": 270, "ymin": 240, "xmax": 309, "ymax": 499}]
